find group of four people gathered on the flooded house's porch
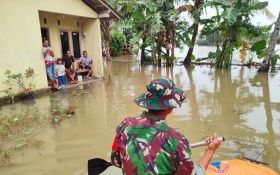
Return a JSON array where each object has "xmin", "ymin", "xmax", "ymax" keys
[{"xmin": 42, "ymin": 39, "xmax": 93, "ymax": 89}]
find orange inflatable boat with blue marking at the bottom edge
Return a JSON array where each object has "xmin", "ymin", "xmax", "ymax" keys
[{"xmin": 206, "ymin": 160, "xmax": 279, "ymax": 175}]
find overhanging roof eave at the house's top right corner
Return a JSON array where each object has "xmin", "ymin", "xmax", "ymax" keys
[{"xmin": 82, "ymin": 0, "xmax": 122, "ymax": 19}]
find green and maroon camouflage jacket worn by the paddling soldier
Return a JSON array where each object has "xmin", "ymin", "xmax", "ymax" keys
[{"xmin": 111, "ymin": 112, "xmax": 204, "ymax": 175}]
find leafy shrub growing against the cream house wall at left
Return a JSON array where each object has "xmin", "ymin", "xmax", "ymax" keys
[{"xmin": 5, "ymin": 67, "xmax": 34, "ymax": 99}]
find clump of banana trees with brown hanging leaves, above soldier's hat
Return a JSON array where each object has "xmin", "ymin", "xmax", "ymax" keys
[{"xmin": 125, "ymin": 0, "xmax": 186, "ymax": 66}]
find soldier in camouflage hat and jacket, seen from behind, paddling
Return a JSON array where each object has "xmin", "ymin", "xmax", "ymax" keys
[{"xmin": 111, "ymin": 78, "xmax": 221, "ymax": 175}]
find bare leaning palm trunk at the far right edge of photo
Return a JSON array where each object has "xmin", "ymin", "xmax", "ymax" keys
[{"xmin": 258, "ymin": 12, "xmax": 280, "ymax": 72}]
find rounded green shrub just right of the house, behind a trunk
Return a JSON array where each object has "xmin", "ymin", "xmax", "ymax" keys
[{"xmin": 110, "ymin": 30, "xmax": 126, "ymax": 56}]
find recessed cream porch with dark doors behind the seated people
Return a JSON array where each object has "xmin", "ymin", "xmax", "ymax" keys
[{"xmin": 39, "ymin": 11, "xmax": 103, "ymax": 77}]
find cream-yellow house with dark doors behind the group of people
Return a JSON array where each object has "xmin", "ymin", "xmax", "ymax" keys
[{"xmin": 0, "ymin": 0, "xmax": 120, "ymax": 96}]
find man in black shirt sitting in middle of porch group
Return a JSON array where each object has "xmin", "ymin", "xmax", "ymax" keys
[{"xmin": 62, "ymin": 50, "xmax": 77, "ymax": 84}]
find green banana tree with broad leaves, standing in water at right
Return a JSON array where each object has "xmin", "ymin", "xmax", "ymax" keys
[{"xmin": 202, "ymin": 0, "xmax": 268, "ymax": 68}]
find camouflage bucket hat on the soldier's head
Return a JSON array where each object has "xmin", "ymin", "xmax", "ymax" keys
[{"xmin": 134, "ymin": 78, "xmax": 186, "ymax": 110}]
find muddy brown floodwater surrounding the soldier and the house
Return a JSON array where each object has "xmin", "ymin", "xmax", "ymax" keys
[{"xmin": 0, "ymin": 58, "xmax": 280, "ymax": 175}]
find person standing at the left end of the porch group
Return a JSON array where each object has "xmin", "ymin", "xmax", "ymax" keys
[{"xmin": 42, "ymin": 39, "xmax": 60, "ymax": 89}]
